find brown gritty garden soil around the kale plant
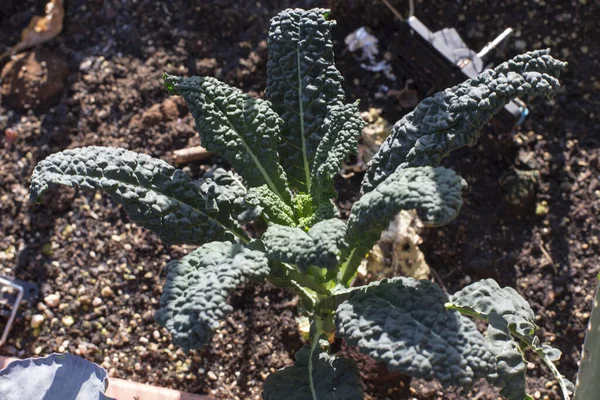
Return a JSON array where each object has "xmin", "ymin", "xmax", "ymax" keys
[{"xmin": 0, "ymin": 0, "xmax": 600, "ymax": 399}]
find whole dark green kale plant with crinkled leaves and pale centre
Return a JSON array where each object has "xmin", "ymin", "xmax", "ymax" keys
[{"xmin": 31, "ymin": 9, "xmax": 570, "ymax": 400}]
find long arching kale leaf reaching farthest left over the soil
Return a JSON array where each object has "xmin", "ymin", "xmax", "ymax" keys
[{"xmin": 31, "ymin": 146, "xmax": 243, "ymax": 244}]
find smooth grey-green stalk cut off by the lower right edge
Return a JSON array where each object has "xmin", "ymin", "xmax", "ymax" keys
[{"xmin": 573, "ymin": 278, "xmax": 600, "ymax": 400}]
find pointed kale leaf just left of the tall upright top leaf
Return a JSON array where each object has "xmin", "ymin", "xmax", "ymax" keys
[{"xmin": 165, "ymin": 75, "xmax": 290, "ymax": 203}]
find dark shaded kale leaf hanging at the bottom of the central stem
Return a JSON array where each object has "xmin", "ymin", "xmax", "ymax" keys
[{"xmin": 262, "ymin": 345, "xmax": 363, "ymax": 400}]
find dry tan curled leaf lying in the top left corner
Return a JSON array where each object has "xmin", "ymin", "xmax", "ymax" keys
[{"xmin": 0, "ymin": 0, "xmax": 65, "ymax": 60}]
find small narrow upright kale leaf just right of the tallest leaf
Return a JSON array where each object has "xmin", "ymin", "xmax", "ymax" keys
[{"xmin": 310, "ymin": 102, "xmax": 365, "ymax": 205}]
